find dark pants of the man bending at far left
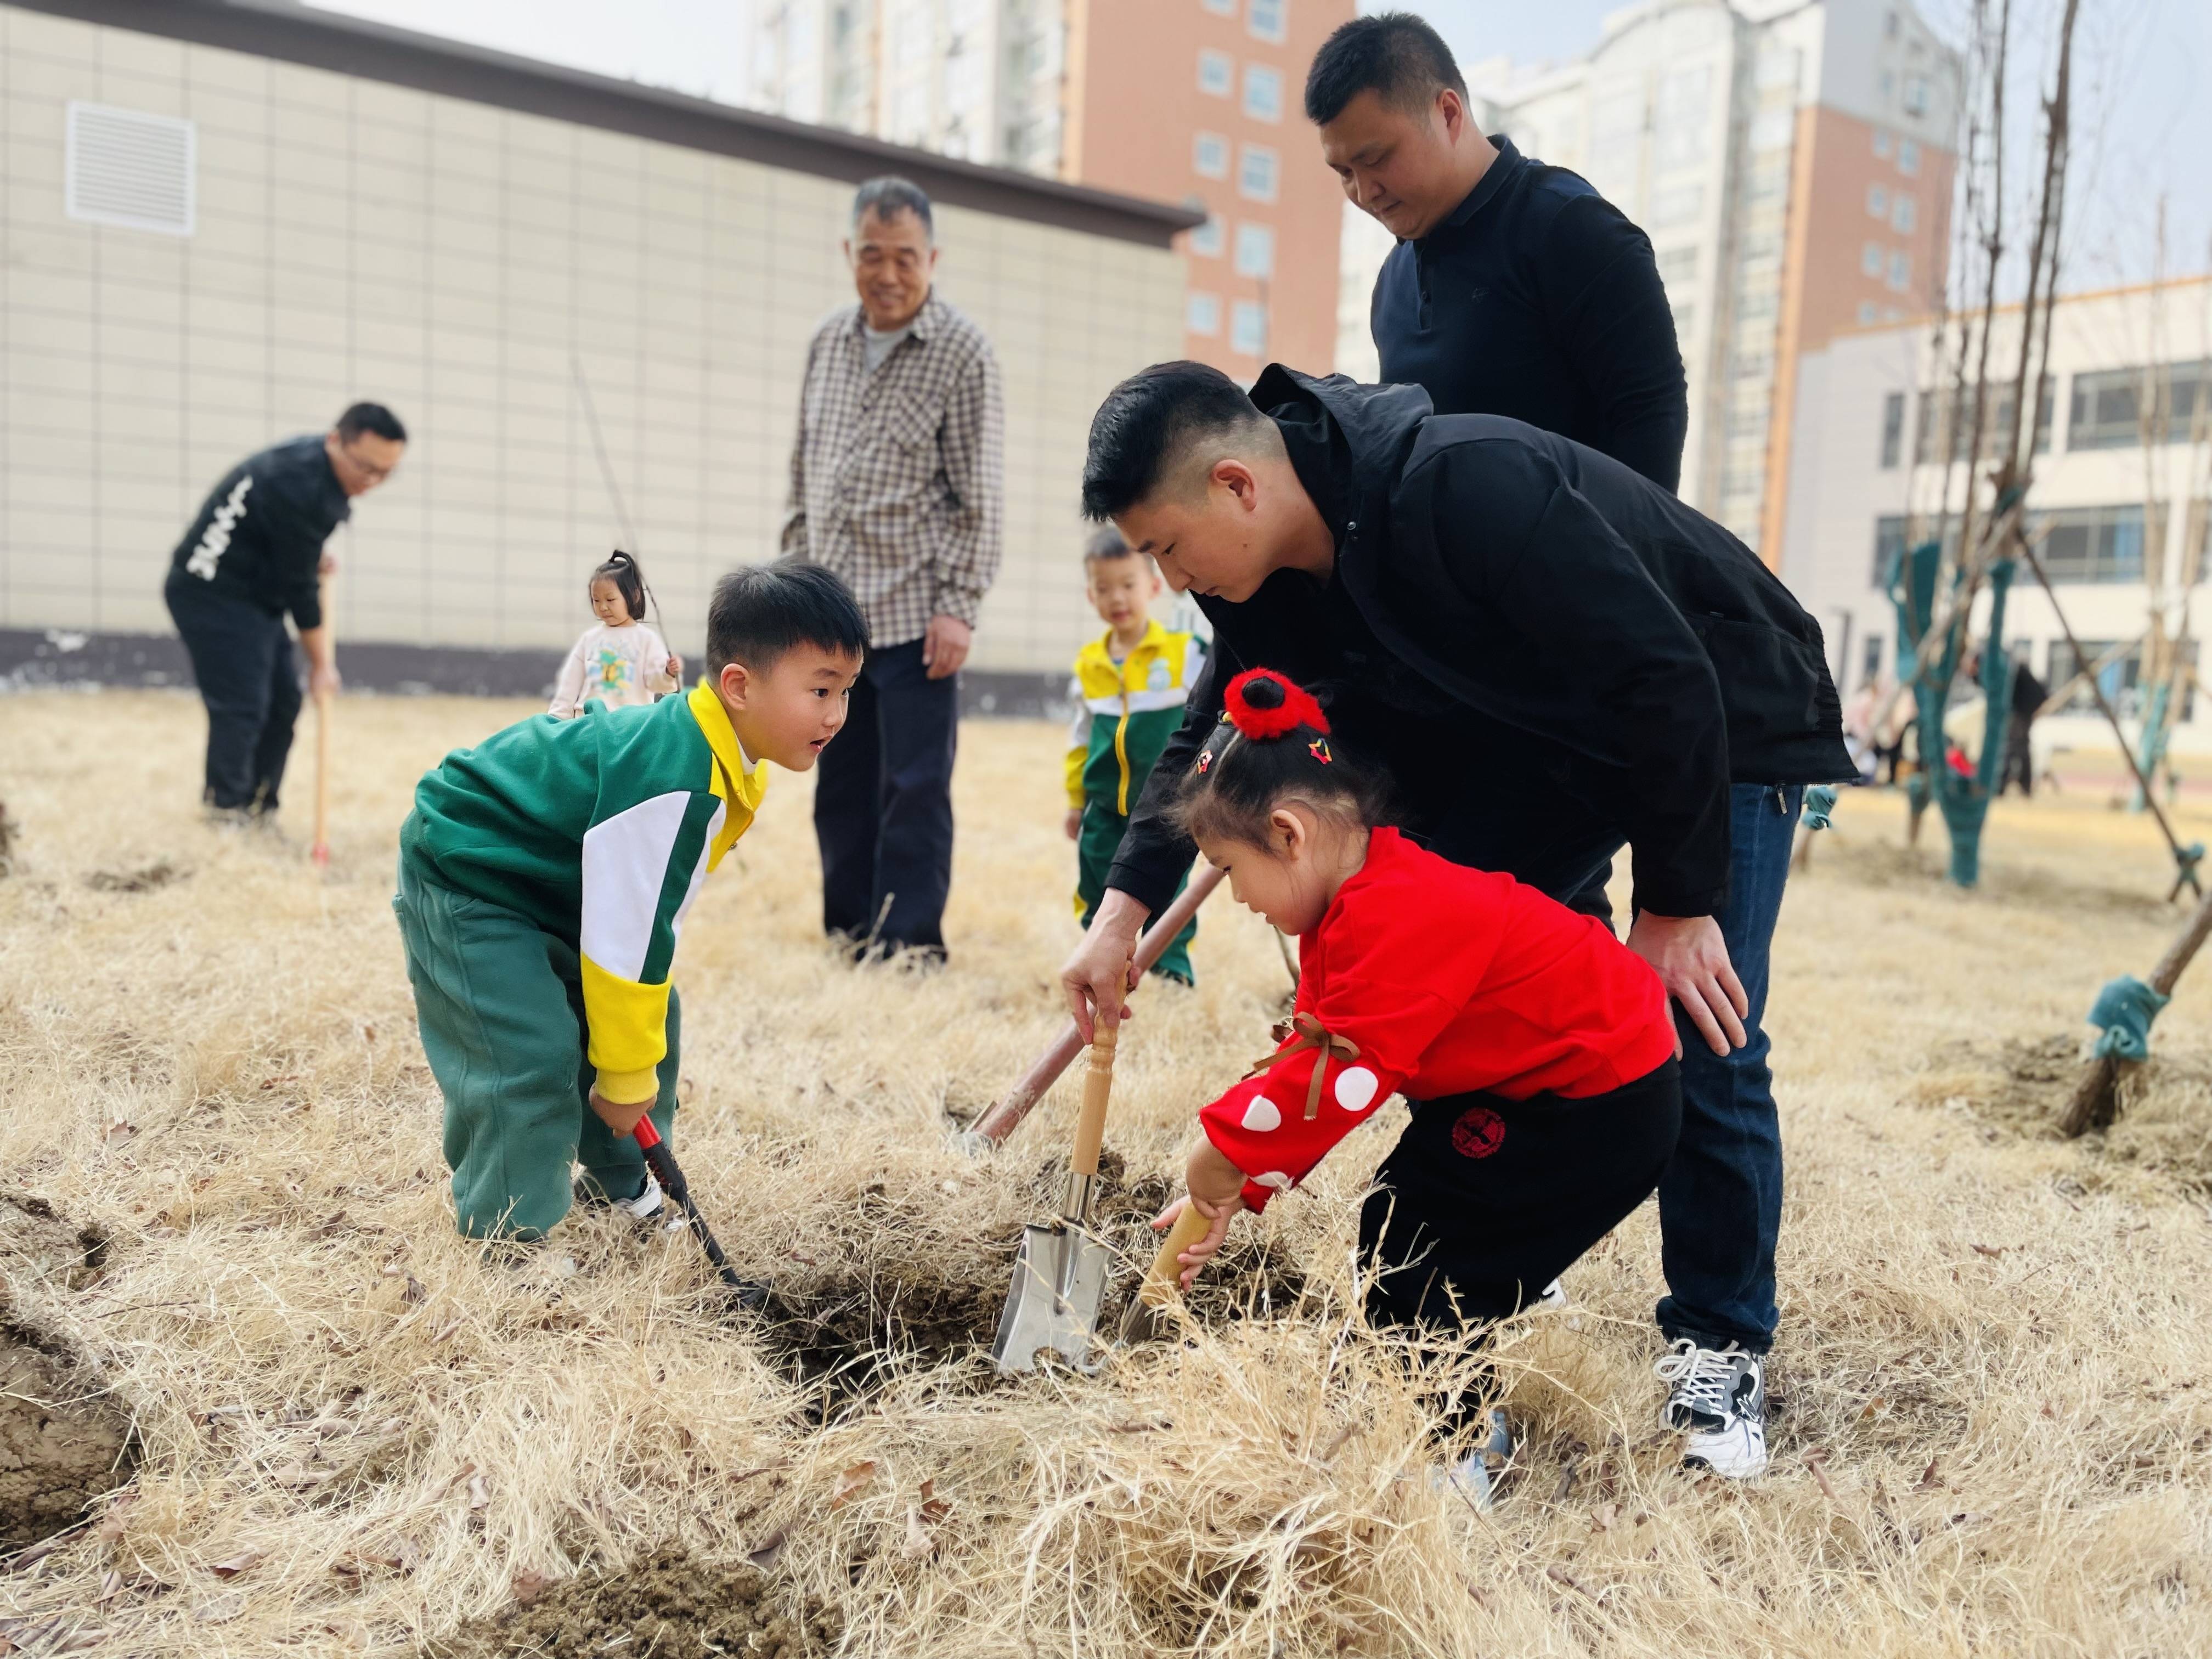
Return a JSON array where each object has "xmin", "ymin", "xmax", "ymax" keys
[{"xmin": 161, "ymin": 575, "xmax": 301, "ymax": 812}]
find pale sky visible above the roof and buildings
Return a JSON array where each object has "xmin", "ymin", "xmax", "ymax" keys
[{"xmin": 317, "ymin": 0, "xmax": 2212, "ymax": 290}]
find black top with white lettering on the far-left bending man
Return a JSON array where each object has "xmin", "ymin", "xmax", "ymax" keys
[{"xmin": 168, "ymin": 433, "xmax": 354, "ymax": 628}]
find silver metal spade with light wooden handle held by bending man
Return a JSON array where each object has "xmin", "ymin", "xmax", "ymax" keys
[{"xmin": 991, "ymin": 1020, "xmax": 1119, "ymax": 1374}]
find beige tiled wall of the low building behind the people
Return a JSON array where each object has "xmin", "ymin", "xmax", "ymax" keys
[{"xmin": 0, "ymin": 7, "xmax": 1183, "ymax": 668}]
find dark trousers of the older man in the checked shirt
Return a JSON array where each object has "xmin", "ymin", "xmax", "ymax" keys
[{"xmin": 814, "ymin": 639, "xmax": 960, "ymax": 956}]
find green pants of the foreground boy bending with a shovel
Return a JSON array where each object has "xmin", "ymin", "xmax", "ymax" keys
[{"xmin": 392, "ymin": 858, "xmax": 679, "ymax": 1239}]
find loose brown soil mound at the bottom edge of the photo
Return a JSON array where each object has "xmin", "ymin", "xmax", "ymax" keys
[{"xmin": 433, "ymin": 1548, "xmax": 843, "ymax": 1659}]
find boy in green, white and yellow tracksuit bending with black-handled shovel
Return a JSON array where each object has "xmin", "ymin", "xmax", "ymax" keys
[{"xmin": 392, "ymin": 564, "xmax": 867, "ymax": 1241}]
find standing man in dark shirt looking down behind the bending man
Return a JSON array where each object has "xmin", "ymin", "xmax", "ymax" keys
[{"xmin": 1305, "ymin": 11, "xmax": 1690, "ymax": 489}]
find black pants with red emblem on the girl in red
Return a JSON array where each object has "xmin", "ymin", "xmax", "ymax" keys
[{"xmin": 1361, "ymin": 1059, "xmax": 1681, "ymax": 1331}]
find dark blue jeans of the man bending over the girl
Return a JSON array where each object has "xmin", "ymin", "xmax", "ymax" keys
[{"xmin": 1659, "ymin": 783, "xmax": 1805, "ymax": 1354}]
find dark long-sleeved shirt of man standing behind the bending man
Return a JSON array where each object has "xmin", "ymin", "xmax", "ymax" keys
[{"xmin": 1369, "ymin": 137, "xmax": 1690, "ymax": 500}]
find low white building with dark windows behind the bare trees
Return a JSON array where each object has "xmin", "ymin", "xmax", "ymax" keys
[{"xmin": 1781, "ymin": 276, "xmax": 2212, "ymax": 752}]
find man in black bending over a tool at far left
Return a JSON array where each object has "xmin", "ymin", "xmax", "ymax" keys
[{"xmin": 161, "ymin": 403, "xmax": 407, "ymax": 825}]
